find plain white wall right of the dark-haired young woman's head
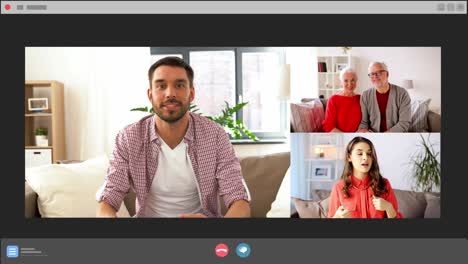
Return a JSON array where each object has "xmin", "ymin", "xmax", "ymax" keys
[{"xmin": 344, "ymin": 133, "xmax": 443, "ymax": 190}]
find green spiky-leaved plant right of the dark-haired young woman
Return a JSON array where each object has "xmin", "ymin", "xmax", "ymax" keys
[{"xmin": 410, "ymin": 135, "xmax": 441, "ymax": 192}]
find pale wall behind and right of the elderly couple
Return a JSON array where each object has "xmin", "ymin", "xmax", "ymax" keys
[{"xmin": 317, "ymin": 47, "xmax": 447, "ymax": 113}]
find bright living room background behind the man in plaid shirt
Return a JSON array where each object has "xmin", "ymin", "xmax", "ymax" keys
[{"xmin": 25, "ymin": 47, "xmax": 290, "ymax": 217}]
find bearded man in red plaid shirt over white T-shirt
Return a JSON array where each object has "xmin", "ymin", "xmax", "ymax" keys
[{"xmin": 98, "ymin": 57, "xmax": 250, "ymax": 218}]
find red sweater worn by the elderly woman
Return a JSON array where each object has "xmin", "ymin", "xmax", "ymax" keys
[{"xmin": 322, "ymin": 94, "xmax": 361, "ymax": 132}]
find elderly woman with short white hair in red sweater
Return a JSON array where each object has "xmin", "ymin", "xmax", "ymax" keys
[{"xmin": 322, "ymin": 67, "xmax": 361, "ymax": 132}]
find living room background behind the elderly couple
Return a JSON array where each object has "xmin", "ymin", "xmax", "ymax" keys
[{"xmin": 290, "ymin": 47, "xmax": 442, "ymax": 132}]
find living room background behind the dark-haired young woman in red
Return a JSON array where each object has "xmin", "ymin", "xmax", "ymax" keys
[{"xmin": 291, "ymin": 133, "xmax": 443, "ymax": 218}]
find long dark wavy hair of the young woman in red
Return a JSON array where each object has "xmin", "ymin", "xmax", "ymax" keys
[{"xmin": 341, "ymin": 137, "xmax": 388, "ymax": 197}]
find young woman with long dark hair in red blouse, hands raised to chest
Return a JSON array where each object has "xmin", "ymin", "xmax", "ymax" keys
[{"xmin": 328, "ymin": 137, "xmax": 402, "ymax": 218}]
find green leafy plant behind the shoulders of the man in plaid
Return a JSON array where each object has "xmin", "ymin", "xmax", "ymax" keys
[{"xmin": 130, "ymin": 101, "xmax": 259, "ymax": 141}]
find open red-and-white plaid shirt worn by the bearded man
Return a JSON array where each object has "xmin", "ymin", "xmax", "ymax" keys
[{"xmin": 100, "ymin": 113, "xmax": 249, "ymax": 217}]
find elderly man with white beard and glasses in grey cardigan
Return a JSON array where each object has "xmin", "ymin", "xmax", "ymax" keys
[{"xmin": 358, "ymin": 62, "xmax": 411, "ymax": 132}]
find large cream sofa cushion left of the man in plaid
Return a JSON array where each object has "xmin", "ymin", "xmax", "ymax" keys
[{"xmin": 26, "ymin": 156, "xmax": 130, "ymax": 217}]
